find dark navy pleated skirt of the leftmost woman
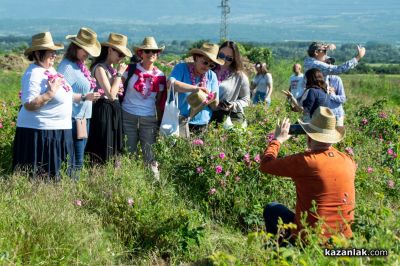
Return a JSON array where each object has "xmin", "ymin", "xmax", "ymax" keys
[{"xmin": 13, "ymin": 127, "xmax": 75, "ymax": 181}]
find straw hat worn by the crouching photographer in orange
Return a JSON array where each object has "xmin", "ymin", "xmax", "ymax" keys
[{"xmin": 298, "ymin": 106, "xmax": 345, "ymax": 143}]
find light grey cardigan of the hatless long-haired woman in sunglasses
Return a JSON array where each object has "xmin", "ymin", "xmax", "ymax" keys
[{"xmin": 219, "ymin": 71, "xmax": 250, "ymax": 113}]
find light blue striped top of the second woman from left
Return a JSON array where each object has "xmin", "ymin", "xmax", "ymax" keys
[{"xmin": 57, "ymin": 58, "xmax": 92, "ymax": 118}]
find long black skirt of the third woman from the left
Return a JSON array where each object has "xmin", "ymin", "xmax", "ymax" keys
[{"xmin": 86, "ymin": 99, "xmax": 123, "ymax": 163}]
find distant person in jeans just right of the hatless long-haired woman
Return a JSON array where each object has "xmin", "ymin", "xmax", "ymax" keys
[{"xmin": 251, "ymin": 62, "xmax": 273, "ymax": 106}]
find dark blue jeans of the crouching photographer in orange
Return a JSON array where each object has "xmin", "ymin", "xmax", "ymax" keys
[{"xmin": 264, "ymin": 202, "xmax": 294, "ymax": 235}]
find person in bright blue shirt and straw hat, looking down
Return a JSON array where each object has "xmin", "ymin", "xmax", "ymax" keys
[{"xmin": 168, "ymin": 43, "xmax": 225, "ymax": 138}]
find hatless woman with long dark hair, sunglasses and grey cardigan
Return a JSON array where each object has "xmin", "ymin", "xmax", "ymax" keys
[{"xmin": 211, "ymin": 41, "xmax": 250, "ymax": 124}]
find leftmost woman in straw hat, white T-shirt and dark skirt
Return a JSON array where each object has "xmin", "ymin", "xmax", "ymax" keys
[{"xmin": 13, "ymin": 32, "xmax": 74, "ymax": 181}]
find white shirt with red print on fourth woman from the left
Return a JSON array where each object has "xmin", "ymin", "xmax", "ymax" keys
[{"xmin": 122, "ymin": 64, "xmax": 164, "ymax": 116}]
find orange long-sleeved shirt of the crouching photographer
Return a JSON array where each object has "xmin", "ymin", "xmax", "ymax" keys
[{"xmin": 260, "ymin": 140, "xmax": 356, "ymax": 237}]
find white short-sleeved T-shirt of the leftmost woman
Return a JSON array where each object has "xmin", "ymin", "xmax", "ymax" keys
[{"xmin": 17, "ymin": 64, "xmax": 73, "ymax": 130}]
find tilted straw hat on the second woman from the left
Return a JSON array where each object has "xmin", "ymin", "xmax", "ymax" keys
[{"xmin": 65, "ymin": 28, "xmax": 101, "ymax": 57}]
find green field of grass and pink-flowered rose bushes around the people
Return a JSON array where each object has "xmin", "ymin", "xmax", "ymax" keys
[{"xmin": 0, "ymin": 58, "xmax": 400, "ymax": 265}]
